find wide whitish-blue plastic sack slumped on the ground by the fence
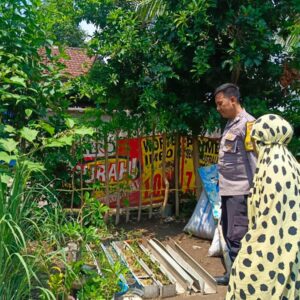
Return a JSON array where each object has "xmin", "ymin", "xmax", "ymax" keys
[{"xmin": 183, "ymin": 191, "xmax": 216, "ymax": 240}]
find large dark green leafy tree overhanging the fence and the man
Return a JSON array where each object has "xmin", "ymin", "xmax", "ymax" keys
[{"xmin": 78, "ymin": 0, "xmax": 299, "ymax": 145}]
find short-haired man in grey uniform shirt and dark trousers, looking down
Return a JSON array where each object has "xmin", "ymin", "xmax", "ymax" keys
[{"xmin": 214, "ymin": 83, "xmax": 256, "ymax": 285}]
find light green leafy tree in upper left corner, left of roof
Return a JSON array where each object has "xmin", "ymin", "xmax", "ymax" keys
[{"xmin": 0, "ymin": 0, "xmax": 72, "ymax": 128}]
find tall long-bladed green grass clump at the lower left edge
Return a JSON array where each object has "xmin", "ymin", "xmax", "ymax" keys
[{"xmin": 0, "ymin": 160, "xmax": 54, "ymax": 300}]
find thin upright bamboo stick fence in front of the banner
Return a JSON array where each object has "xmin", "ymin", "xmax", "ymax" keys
[{"xmin": 58, "ymin": 133, "xmax": 216, "ymax": 225}]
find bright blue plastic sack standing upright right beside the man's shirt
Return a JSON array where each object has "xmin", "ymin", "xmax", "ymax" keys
[{"xmin": 198, "ymin": 165, "xmax": 221, "ymax": 219}]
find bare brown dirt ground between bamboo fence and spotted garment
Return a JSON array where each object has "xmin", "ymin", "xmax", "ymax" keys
[{"xmin": 119, "ymin": 214, "xmax": 226, "ymax": 300}]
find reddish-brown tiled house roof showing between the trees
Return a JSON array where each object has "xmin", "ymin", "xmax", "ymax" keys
[{"xmin": 41, "ymin": 47, "xmax": 95, "ymax": 77}]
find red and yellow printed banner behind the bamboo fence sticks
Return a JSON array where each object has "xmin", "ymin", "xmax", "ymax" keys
[{"xmin": 77, "ymin": 136, "xmax": 219, "ymax": 207}]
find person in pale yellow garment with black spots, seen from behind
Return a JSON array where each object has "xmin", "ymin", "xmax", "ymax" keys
[{"xmin": 226, "ymin": 114, "xmax": 300, "ymax": 300}]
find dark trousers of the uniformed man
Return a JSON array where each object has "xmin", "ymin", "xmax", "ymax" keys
[{"xmin": 221, "ymin": 195, "xmax": 248, "ymax": 261}]
